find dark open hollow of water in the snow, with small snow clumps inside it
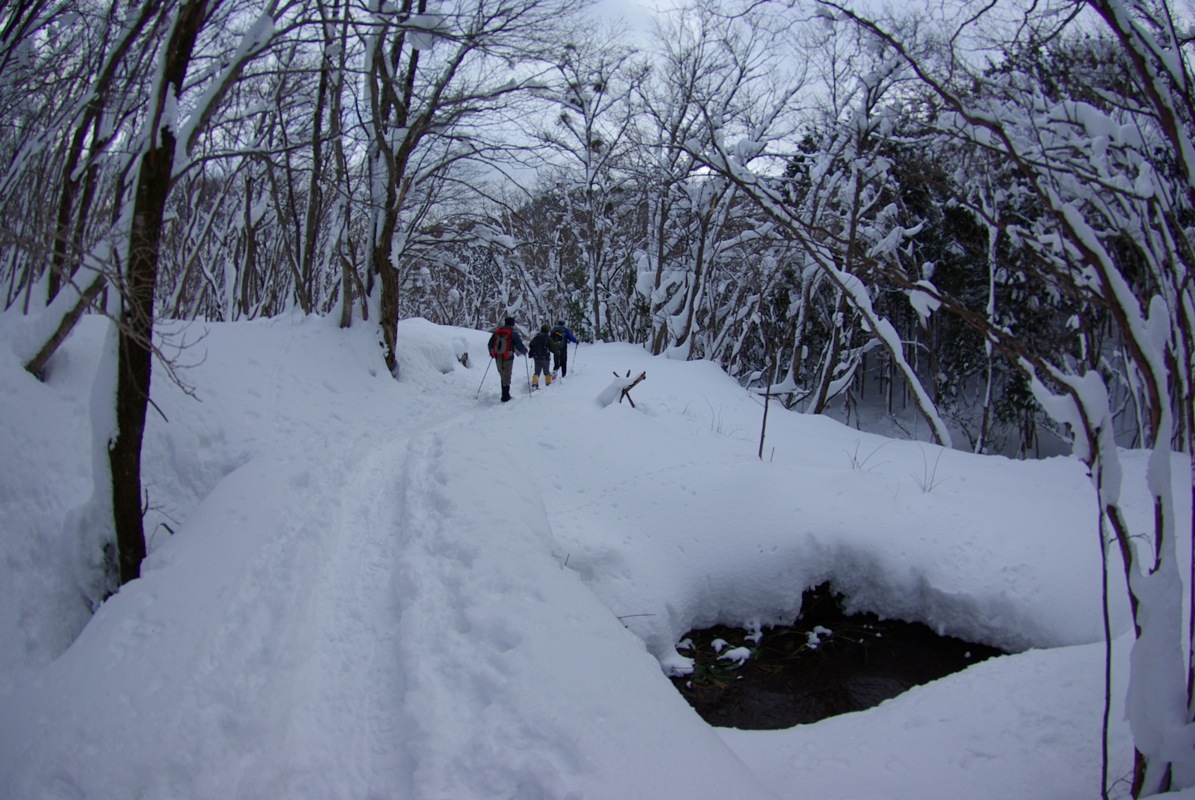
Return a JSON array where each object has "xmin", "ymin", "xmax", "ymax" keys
[{"xmin": 673, "ymin": 584, "xmax": 1003, "ymax": 729}]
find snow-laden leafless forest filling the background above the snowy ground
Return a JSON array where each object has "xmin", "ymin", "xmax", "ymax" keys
[{"xmin": 0, "ymin": 0, "xmax": 1195, "ymax": 796}]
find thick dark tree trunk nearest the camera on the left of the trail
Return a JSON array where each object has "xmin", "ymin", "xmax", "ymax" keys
[{"xmin": 39, "ymin": 0, "xmax": 282, "ymax": 582}]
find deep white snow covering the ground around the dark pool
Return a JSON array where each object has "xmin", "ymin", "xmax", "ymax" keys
[{"xmin": 0, "ymin": 314, "xmax": 1190, "ymax": 800}]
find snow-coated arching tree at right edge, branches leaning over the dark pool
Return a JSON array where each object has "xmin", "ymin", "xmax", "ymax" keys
[{"xmin": 803, "ymin": 0, "xmax": 1195, "ymax": 796}]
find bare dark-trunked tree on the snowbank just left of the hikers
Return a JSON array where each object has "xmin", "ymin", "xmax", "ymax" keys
[{"xmin": 359, "ymin": 0, "xmax": 592, "ymax": 374}]
